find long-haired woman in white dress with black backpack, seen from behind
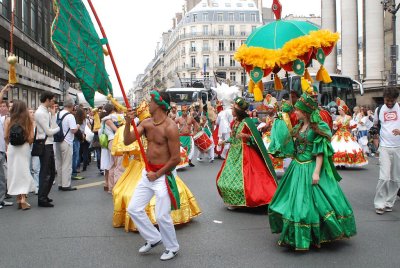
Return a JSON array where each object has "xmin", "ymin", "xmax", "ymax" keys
[{"xmin": 4, "ymin": 100, "xmax": 34, "ymax": 210}]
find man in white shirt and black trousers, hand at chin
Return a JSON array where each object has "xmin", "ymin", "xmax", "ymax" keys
[{"xmin": 35, "ymin": 91, "xmax": 60, "ymax": 207}]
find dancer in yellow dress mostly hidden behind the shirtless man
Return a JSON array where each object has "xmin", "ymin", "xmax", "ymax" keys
[{"xmin": 112, "ymin": 102, "xmax": 201, "ymax": 232}]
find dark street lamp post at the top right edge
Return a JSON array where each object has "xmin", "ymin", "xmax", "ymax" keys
[{"xmin": 381, "ymin": 0, "xmax": 400, "ymax": 85}]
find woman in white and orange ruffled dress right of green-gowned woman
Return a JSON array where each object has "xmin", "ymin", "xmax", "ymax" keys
[{"xmin": 332, "ymin": 98, "xmax": 368, "ymax": 167}]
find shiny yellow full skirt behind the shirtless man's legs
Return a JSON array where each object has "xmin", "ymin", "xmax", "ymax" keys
[{"xmin": 113, "ymin": 156, "xmax": 201, "ymax": 232}]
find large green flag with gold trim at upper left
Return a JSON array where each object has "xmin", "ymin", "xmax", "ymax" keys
[{"xmin": 51, "ymin": 0, "xmax": 112, "ymax": 107}]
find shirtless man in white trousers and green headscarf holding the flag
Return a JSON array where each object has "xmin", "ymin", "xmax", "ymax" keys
[{"xmin": 124, "ymin": 91, "xmax": 180, "ymax": 261}]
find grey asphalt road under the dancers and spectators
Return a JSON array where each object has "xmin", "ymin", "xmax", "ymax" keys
[{"xmin": 0, "ymin": 158, "xmax": 400, "ymax": 268}]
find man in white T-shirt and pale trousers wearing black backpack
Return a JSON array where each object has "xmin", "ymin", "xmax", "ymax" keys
[{"xmin": 56, "ymin": 99, "xmax": 79, "ymax": 191}]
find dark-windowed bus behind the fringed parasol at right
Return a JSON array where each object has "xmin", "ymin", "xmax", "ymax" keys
[{"xmin": 264, "ymin": 74, "xmax": 364, "ymax": 110}]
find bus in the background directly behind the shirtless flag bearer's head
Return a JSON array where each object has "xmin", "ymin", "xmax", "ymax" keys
[{"xmin": 165, "ymin": 87, "xmax": 215, "ymax": 106}]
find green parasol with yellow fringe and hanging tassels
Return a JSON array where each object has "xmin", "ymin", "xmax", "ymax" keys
[{"xmin": 235, "ymin": 0, "xmax": 339, "ymax": 101}]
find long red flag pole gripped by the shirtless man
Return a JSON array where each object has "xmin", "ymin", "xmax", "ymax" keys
[{"xmin": 88, "ymin": 0, "xmax": 149, "ymax": 170}]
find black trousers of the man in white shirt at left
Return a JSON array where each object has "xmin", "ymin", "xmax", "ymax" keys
[{"xmin": 38, "ymin": 144, "xmax": 56, "ymax": 202}]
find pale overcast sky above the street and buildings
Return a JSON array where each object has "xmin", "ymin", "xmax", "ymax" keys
[{"xmin": 83, "ymin": 0, "xmax": 321, "ymax": 96}]
